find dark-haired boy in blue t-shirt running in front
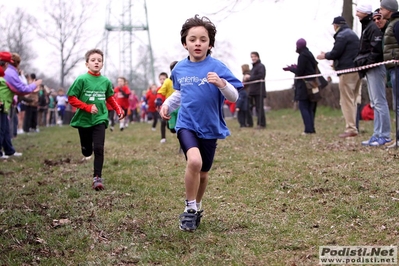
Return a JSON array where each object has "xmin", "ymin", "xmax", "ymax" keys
[{"xmin": 160, "ymin": 15, "xmax": 243, "ymax": 231}]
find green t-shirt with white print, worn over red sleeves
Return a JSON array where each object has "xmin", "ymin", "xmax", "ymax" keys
[{"xmin": 67, "ymin": 73, "xmax": 114, "ymax": 127}]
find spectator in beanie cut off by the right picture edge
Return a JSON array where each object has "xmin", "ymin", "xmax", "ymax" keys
[{"xmin": 380, "ymin": 0, "xmax": 399, "ymax": 148}]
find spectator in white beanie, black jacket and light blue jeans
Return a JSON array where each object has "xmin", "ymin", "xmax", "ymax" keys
[{"xmin": 354, "ymin": 1, "xmax": 392, "ymax": 146}]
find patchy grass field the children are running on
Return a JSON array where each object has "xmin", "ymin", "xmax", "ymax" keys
[{"xmin": 0, "ymin": 108, "xmax": 399, "ymax": 266}]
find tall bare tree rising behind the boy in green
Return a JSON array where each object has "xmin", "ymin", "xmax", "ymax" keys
[{"xmin": 40, "ymin": 0, "xmax": 99, "ymax": 87}]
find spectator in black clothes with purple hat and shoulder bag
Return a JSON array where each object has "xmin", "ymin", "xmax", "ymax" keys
[{"xmin": 283, "ymin": 38, "xmax": 318, "ymax": 134}]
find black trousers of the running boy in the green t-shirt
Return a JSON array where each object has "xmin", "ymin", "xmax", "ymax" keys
[{"xmin": 78, "ymin": 124, "xmax": 105, "ymax": 177}]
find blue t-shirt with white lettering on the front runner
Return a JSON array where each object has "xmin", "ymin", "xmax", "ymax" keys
[{"xmin": 171, "ymin": 56, "xmax": 243, "ymax": 139}]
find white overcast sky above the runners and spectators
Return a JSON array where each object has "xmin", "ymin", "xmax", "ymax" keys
[{"xmin": 0, "ymin": 0, "xmax": 380, "ymax": 91}]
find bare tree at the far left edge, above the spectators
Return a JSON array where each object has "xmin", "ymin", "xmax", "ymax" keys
[{"xmin": 0, "ymin": 7, "xmax": 37, "ymax": 69}]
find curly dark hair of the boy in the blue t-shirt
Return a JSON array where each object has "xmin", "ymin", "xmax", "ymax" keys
[{"xmin": 180, "ymin": 14, "xmax": 216, "ymax": 55}]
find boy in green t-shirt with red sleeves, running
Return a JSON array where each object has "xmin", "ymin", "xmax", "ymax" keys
[{"xmin": 67, "ymin": 49, "xmax": 125, "ymax": 190}]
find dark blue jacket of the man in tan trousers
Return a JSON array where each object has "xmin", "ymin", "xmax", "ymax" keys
[{"xmin": 325, "ymin": 25, "xmax": 360, "ymax": 73}]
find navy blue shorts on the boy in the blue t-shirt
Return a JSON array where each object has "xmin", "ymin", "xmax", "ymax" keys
[{"xmin": 177, "ymin": 129, "xmax": 217, "ymax": 172}]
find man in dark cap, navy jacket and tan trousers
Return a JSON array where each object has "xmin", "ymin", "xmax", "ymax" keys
[{"xmin": 317, "ymin": 17, "xmax": 360, "ymax": 138}]
